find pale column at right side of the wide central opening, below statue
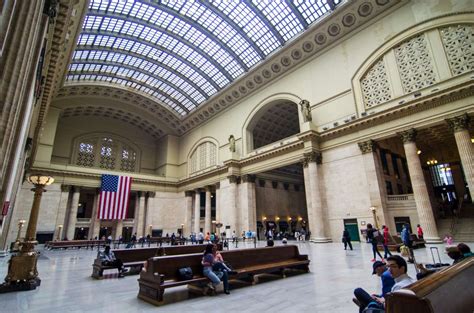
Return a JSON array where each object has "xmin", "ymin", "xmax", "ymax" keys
[{"xmin": 304, "ymin": 151, "xmax": 331, "ymax": 243}]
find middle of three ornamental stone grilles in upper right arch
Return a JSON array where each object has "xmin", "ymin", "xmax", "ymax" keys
[{"xmin": 394, "ymin": 34, "xmax": 436, "ymax": 93}]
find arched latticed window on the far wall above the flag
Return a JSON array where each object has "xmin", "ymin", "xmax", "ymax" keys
[{"xmin": 73, "ymin": 134, "xmax": 139, "ymax": 172}]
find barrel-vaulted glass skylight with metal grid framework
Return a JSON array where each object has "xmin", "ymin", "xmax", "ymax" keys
[{"xmin": 66, "ymin": 0, "xmax": 341, "ymax": 116}]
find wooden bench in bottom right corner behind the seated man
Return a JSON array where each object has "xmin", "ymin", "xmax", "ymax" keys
[{"xmin": 386, "ymin": 257, "xmax": 474, "ymax": 313}]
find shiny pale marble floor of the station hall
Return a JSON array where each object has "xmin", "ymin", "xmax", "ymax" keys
[{"xmin": 0, "ymin": 241, "xmax": 468, "ymax": 313}]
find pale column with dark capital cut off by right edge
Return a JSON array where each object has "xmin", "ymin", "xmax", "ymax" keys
[{"xmin": 447, "ymin": 114, "xmax": 474, "ymax": 201}]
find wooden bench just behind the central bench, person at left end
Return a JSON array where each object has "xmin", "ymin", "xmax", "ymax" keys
[{"xmin": 91, "ymin": 245, "xmax": 214, "ymax": 279}]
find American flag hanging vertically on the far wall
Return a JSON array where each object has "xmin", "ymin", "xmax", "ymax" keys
[{"xmin": 97, "ymin": 175, "xmax": 132, "ymax": 220}]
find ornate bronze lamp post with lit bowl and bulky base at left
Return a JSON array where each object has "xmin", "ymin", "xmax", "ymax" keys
[{"xmin": 0, "ymin": 174, "xmax": 54, "ymax": 293}]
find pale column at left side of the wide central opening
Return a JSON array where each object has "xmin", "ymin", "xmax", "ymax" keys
[{"xmin": 240, "ymin": 174, "xmax": 257, "ymax": 231}]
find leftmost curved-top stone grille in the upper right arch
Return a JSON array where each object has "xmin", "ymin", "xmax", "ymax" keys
[{"xmin": 360, "ymin": 59, "xmax": 392, "ymax": 107}]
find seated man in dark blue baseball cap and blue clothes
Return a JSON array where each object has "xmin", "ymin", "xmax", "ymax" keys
[{"xmin": 352, "ymin": 261, "xmax": 395, "ymax": 312}]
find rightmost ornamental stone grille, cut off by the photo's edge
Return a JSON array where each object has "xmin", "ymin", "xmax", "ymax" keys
[{"xmin": 440, "ymin": 25, "xmax": 474, "ymax": 75}]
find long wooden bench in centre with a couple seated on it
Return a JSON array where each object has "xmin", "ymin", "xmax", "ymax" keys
[{"xmin": 138, "ymin": 245, "xmax": 310, "ymax": 305}]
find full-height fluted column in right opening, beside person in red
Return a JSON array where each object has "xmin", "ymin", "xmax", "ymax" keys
[{"xmin": 400, "ymin": 129, "xmax": 441, "ymax": 243}]
